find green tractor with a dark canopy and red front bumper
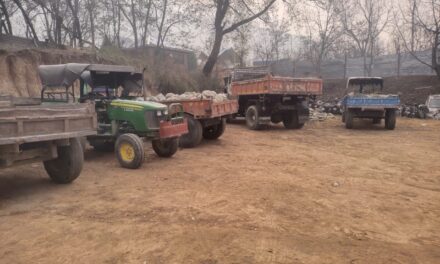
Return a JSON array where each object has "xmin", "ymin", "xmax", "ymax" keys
[{"xmin": 39, "ymin": 63, "xmax": 188, "ymax": 169}]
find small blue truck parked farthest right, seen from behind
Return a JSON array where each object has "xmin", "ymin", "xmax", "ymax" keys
[{"xmin": 341, "ymin": 77, "xmax": 400, "ymax": 130}]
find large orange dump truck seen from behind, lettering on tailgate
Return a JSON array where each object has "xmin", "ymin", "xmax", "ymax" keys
[{"xmin": 225, "ymin": 70, "xmax": 322, "ymax": 130}]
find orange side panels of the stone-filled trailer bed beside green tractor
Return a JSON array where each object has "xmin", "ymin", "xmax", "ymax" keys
[{"xmin": 161, "ymin": 99, "xmax": 238, "ymax": 119}]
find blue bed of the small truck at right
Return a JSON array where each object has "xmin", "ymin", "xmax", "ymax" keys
[{"xmin": 344, "ymin": 94, "xmax": 400, "ymax": 109}]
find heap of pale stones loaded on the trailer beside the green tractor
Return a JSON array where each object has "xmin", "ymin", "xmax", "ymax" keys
[{"xmin": 147, "ymin": 90, "xmax": 228, "ymax": 102}]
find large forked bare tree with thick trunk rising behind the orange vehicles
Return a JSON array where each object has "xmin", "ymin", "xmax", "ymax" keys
[{"xmin": 203, "ymin": 0, "xmax": 276, "ymax": 76}]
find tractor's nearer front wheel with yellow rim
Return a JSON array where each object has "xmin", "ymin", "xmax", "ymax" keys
[{"xmin": 115, "ymin": 133, "xmax": 144, "ymax": 169}]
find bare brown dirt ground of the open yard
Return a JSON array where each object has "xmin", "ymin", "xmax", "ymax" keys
[{"xmin": 0, "ymin": 119, "xmax": 440, "ymax": 264}]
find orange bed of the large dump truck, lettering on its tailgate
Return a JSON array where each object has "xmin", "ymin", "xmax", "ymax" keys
[{"xmin": 230, "ymin": 75, "xmax": 322, "ymax": 96}]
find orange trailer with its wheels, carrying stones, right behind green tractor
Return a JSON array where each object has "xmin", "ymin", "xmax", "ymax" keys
[{"xmin": 161, "ymin": 99, "xmax": 238, "ymax": 148}]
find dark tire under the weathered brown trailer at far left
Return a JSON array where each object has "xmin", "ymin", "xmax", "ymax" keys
[{"xmin": 43, "ymin": 138, "xmax": 84, "ymax": 184}]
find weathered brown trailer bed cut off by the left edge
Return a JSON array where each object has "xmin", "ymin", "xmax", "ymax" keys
[{"xmin": 0, "ymin": 101, "xmax": 97, "ymax": 145}]
